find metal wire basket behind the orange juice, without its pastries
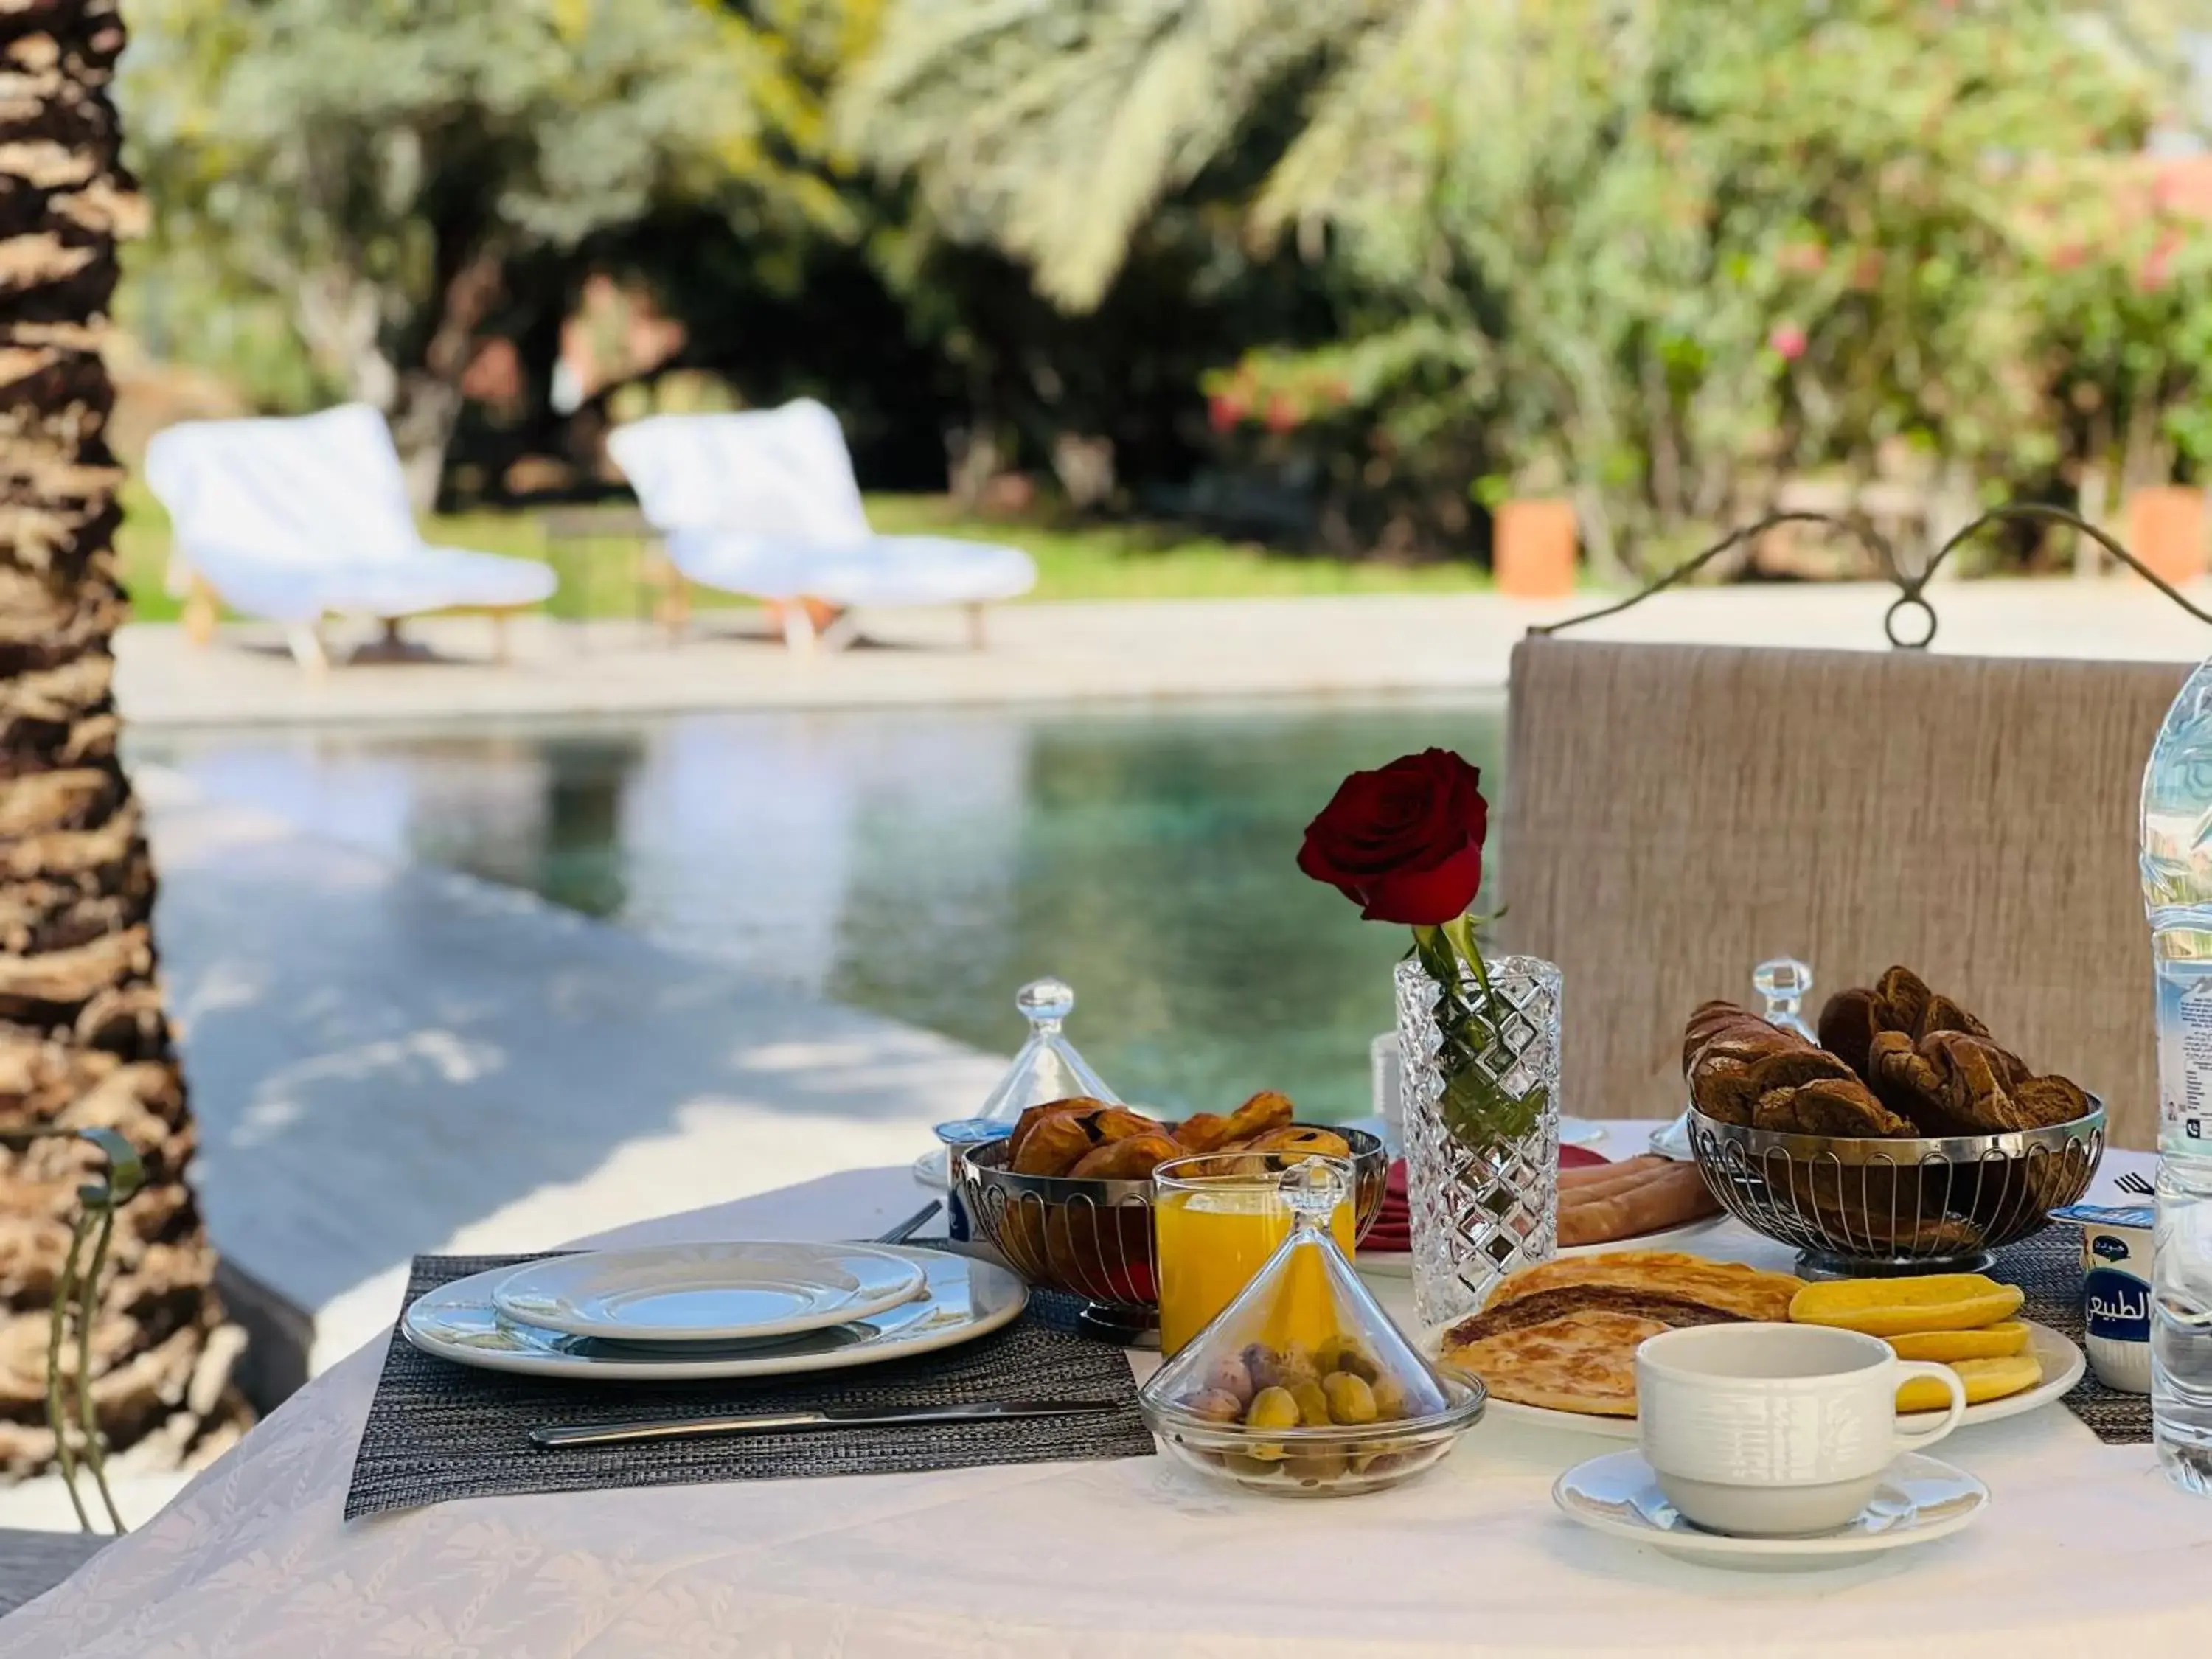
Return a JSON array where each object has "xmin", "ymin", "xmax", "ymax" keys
[{"xmin": 958, "ymin": 1124, "xmax": 1389, "ymax": 1347}]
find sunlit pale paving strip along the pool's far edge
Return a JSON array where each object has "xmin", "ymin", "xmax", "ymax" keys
[{"xmin": 119, "ymin": 577, "xmax": 2212, "ymax": 726}]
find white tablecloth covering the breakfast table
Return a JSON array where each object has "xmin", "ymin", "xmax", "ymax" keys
[{"xmin": 0, "ymin": 1126, "xmax": 2212, "ymax": 1659}]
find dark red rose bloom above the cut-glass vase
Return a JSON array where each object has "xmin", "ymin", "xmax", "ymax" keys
[{"xmin": 1298, "ymin": 750, "xmax": 1489, "ymax": 927}]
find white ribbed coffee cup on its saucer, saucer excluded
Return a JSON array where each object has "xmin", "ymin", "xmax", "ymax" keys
[{"xmin": 1637, "ymin": 1325, "xmax": 1966, "ymax": 1537}]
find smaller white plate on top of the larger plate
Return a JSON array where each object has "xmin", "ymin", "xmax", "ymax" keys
[{"xmin": 491, "ymin": 1241, "xmax": 922, "ymax": 1343}]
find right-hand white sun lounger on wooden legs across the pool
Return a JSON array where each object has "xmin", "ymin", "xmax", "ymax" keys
[{"xmin": 606, "ymin": 398, "xmax": 1037, "ymax": 648}]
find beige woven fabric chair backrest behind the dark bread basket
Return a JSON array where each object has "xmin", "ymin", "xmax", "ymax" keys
[{"xmin": 1500, "ymin": 637, "xmax": 2188, "ymax": 1146}]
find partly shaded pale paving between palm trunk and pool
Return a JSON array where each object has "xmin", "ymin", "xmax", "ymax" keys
[{"xmin": 142, "ymin": 770, "xmax": 1004, "ymax": 1371}]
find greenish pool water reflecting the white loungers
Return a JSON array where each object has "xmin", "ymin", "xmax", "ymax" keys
[{"xmin": 133, "ymin": 701, "xmax": 1504, "ymax": 1117}]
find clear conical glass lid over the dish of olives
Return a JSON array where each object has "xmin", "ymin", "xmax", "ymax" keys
[{"xmin": 1144, "ymin": 1157, "xmax": 1451, "ymax": 1431}]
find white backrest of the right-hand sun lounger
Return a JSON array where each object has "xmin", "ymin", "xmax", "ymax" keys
[{"xmin": 606, "ymin": 398, "xmax": 869, "ymax": 546}]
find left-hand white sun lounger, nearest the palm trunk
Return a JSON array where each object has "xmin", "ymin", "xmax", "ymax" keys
[{"xmin": 146, "ymin": 403, "xmax": 555, "ymax": 668}]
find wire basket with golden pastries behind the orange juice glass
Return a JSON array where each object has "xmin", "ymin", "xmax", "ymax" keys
[{"xmin": 960, "ymin": 1091, "xmax": 1389, "ymax": 1340}]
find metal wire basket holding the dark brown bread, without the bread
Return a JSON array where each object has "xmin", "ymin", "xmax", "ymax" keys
[{"xmin": 1690, "ymin": 1095, "xmax": 2104, "ymax": 1279}]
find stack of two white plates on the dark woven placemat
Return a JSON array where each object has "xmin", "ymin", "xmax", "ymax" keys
[{"xmin": 400, "ymin": 1243, "xmax": 1029, "ymax": 1382}]
